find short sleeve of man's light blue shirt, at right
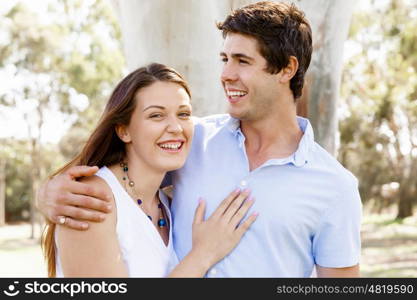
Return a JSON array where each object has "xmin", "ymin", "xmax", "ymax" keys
[{"xmin": 313, "ymin": 178, "xmax": 362, "ymax": 268}]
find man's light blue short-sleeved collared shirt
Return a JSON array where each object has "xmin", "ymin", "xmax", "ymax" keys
[{"xmin": 171, "ymin": 115, "xmax": 362, "ymax": 277}]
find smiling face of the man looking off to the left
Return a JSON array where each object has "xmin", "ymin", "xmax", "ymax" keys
[{"xmin": 220, "ymin": 33, "xmax": 280, "ymax": 121}]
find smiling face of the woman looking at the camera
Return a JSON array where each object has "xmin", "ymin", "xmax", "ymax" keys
[{"xmin": 118, "ymin": 81, "xmax": 194, "ymax": 172}]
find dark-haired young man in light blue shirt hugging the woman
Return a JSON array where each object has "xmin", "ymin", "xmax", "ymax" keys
[{"xmin": 40, "ymin": 2, "xmax": 361, "ymax": 277}]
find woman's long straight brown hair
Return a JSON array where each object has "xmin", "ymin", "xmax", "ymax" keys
[{"xmin": 42, "ymin": 63, "xmax": 191, "ymax": 277}]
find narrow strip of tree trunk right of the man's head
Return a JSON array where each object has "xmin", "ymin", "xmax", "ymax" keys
[{"xmin": 296, "ymin": 0, "xmax": 355, "ymax": 155}]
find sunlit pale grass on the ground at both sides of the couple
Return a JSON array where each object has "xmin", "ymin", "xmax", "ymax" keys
[{"xmin": 0, "ymin": 212, "xmax": 417, "ymax": 277}]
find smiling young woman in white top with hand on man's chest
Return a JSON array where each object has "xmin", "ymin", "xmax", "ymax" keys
[{"xmin": 42, "ymin": 64, "xmax": 256, "ymax": 277}]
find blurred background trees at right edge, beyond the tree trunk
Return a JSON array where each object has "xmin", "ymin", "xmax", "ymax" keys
[{"xmin": 339, "ymin": 0, "xmax": 417, "ymax": 219}]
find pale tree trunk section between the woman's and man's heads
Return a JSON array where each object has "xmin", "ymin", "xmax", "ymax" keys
[{"xmin": 109, "ymin": 0, "xmax": 230, "ymax": 116}]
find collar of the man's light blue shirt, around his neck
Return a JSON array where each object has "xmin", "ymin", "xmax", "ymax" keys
[{"xmin": 226, "ymin": 116, "xmax": 314, "ymax": 167}]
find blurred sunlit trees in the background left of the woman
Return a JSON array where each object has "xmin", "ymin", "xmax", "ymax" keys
[{"xmin": 0, "ymin": 0, "xmax": 124, "ymax": 236}]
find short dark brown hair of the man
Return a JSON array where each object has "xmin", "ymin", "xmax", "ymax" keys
[{"xmin": 217, "ymin": 1, "xmax": 313, "ymax": 99}]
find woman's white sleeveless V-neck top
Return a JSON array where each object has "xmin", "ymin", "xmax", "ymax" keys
[{"xmin": 55, "ymin": 167, "xmax": 178, "ymax": 277}]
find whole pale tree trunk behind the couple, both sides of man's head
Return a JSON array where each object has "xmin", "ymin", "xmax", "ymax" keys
[{"xmin": 112, "ymin": 0, "xmax": 354, "ymax": 154}]
